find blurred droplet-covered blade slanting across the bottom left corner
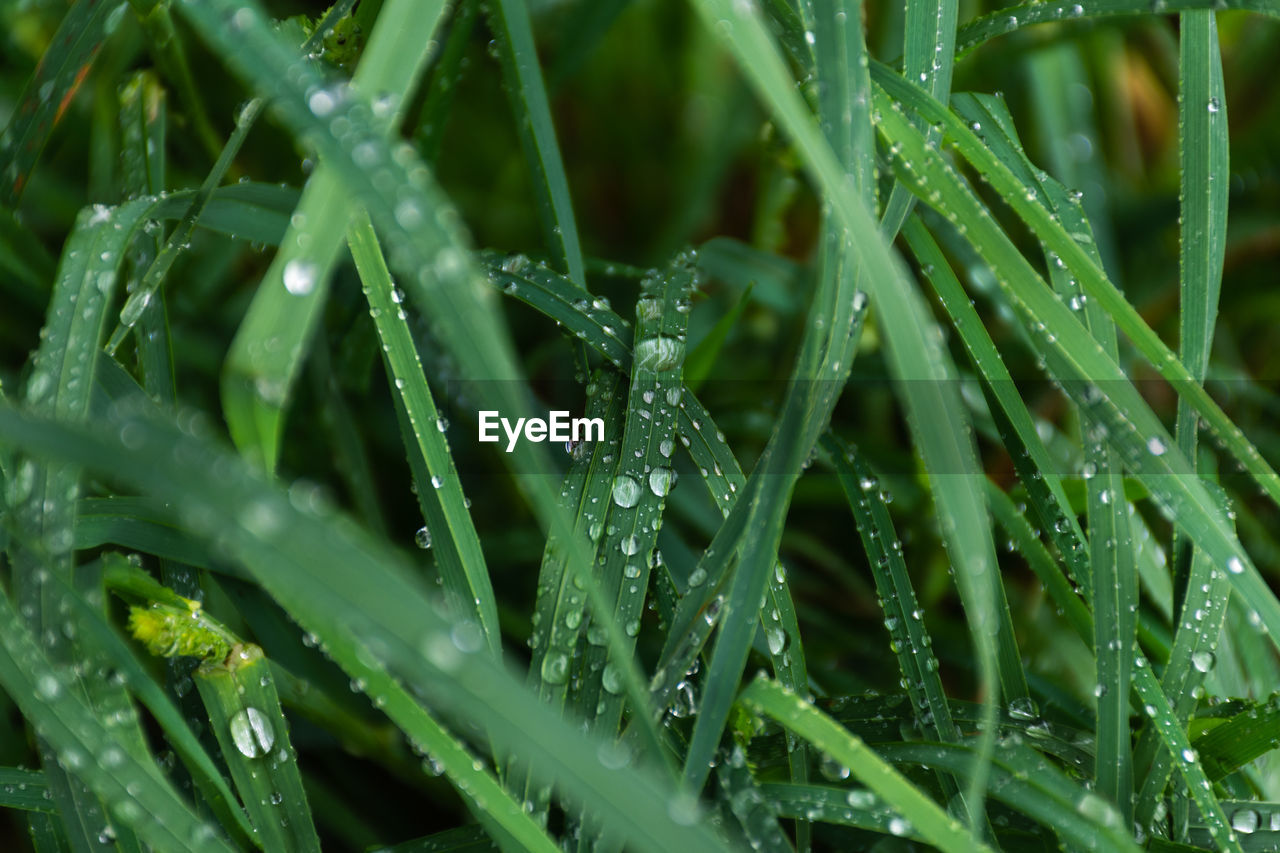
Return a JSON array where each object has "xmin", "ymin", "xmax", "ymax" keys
[{"xmin": 0, "ymin": 581, "xmax": 233, "ymax": 853}]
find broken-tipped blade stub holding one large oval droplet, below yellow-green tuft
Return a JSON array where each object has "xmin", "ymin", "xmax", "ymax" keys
[{"xmin": 195, "ymin": 643, "xmax": 320, "ymax": 850}]
